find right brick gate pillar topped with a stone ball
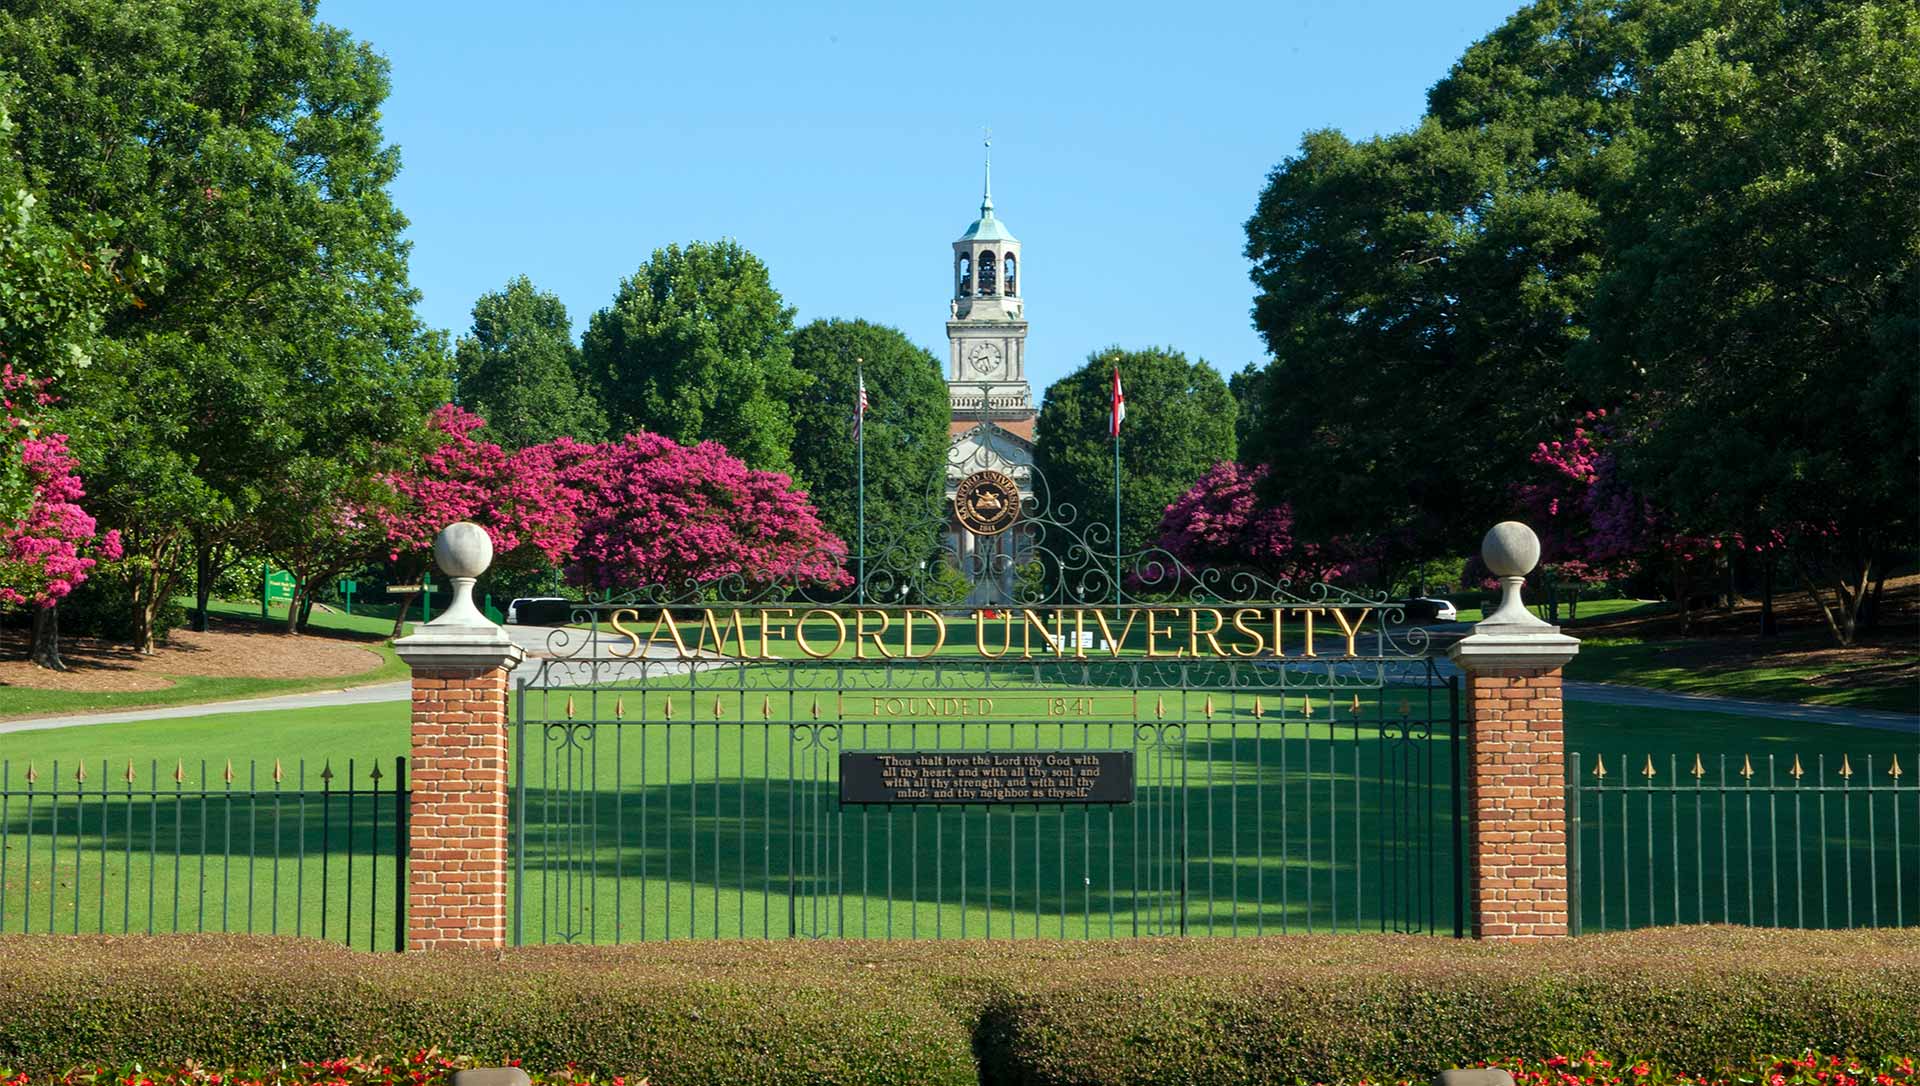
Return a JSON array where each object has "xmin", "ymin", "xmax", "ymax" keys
[{"xmin": 1448, "ymin": 520, "xmax": 1580, "ymax": 940}]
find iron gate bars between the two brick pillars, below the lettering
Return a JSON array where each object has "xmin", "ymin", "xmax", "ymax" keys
[{"xmin": 511, "ymin": 662, "xmax": 1467, "ymax": 942}]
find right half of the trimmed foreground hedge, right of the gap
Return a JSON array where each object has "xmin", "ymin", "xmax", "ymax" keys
[{"xmin": 977, "ymin": 929, "xmax": 1920, "ymax": 1084}]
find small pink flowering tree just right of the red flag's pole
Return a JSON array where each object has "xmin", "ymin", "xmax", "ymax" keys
[{"xmin": 1154, "ymin": 460, "xmax": 1352, "ymax": 583}]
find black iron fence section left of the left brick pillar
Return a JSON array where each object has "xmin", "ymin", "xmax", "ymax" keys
[{"xmin": 0, "ymin": 758, "xmax": 409, "ymax": 950}]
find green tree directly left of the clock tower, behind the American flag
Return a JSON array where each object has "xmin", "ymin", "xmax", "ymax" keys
[{"xmin": 793, "ymin": 320, "xmax": 948, "ymax": 578}]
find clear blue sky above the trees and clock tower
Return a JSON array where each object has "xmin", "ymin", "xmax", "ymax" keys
[{"xmin": 321, "ymin": 0, "xmax": 1517, "ymax": 391}]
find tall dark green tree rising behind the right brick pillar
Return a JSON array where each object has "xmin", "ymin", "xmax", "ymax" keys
[{"xmin": 1246, "ymin": 0, "xmax": 1653, "ymax": 570}]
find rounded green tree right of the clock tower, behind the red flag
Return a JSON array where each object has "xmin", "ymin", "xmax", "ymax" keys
[{"xmin": 1035, "ymin": 347, "xmax": 1236, "ymax": 553}]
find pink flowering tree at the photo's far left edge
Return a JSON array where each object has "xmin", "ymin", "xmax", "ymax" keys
[{"xmin": 0, "ymin": 434, "xmax": 121, "ymax": 670}]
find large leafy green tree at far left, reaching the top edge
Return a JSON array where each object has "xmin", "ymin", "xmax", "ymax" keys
[{"xmin": 0, "ymin": 0, "xmax": 445, "ymax": 652}]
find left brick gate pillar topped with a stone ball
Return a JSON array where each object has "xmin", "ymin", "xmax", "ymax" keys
[{"xmin": 394, "ymin": 524, "xmax": 524, "ymax": 950}]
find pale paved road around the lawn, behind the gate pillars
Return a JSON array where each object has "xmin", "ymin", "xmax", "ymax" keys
[{"xmin": 0, "ymin": 637, "xmax": 1920, "ymax": 735}]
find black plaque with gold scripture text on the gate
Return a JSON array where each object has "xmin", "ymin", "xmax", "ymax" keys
[{"xmin": 841, "ymin": 750, "xmax": 1133, "ymax": 804}]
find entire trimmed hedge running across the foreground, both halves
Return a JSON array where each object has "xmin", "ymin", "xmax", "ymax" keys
[{"xmin": 0, "ymin": 929, "xmax": 1920, "ymax": 1086}]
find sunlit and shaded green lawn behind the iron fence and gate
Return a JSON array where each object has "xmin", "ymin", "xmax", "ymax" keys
[{"xmin": 0, "ymin": 687, "xmax": 1920, "ymax": 946}]
